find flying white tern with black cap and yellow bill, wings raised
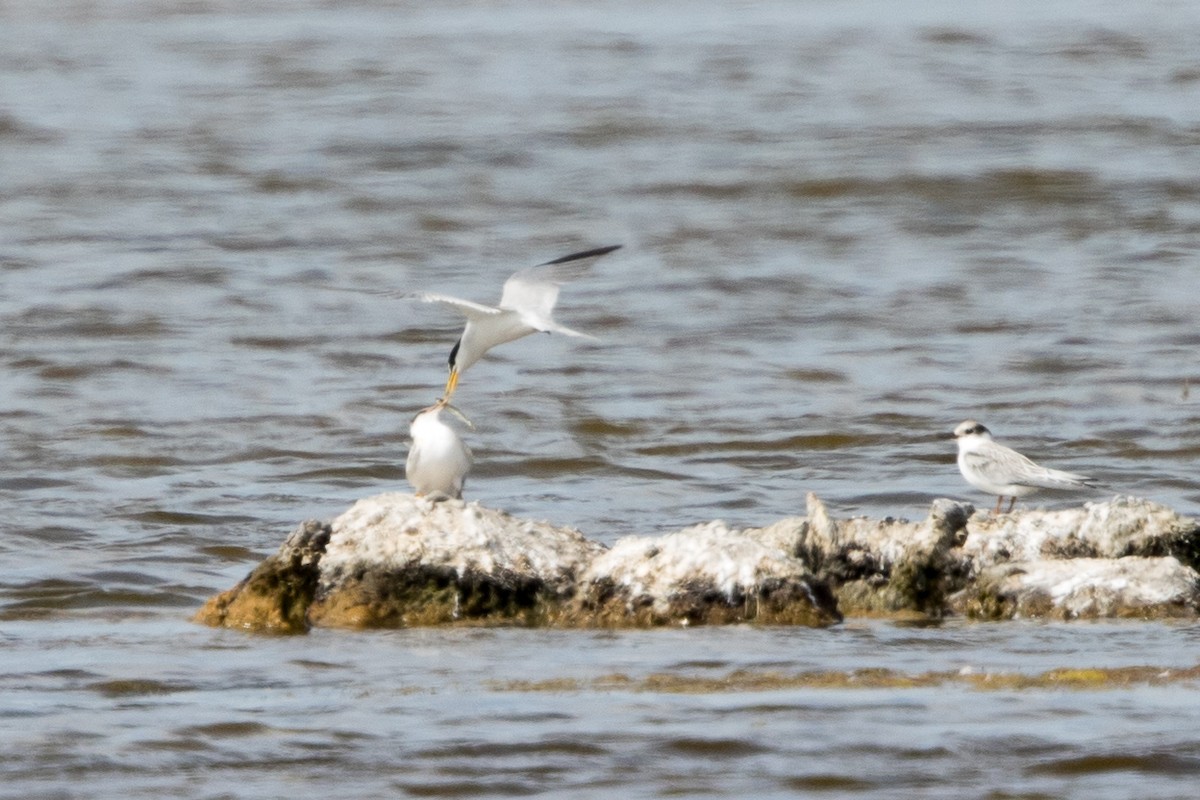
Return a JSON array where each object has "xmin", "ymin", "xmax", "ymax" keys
[{"xmin": 416, "ymin": 245, "xmax": 620, "ymax": 399}]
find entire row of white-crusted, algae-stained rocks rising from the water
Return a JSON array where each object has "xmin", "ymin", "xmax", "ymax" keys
[{"xmin": 196, "ymin": 493, "xmax": 1200, "ymax": 631}]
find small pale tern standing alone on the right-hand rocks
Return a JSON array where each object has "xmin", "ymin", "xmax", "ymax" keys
[{"xmin": 954, "ymin": 420, "xmax": 1096, "ymax": 515}]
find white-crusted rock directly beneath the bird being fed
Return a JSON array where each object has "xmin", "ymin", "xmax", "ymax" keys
[{"xmin": 310, "ymin": 493, "xmax": 604, "ymax": 627}]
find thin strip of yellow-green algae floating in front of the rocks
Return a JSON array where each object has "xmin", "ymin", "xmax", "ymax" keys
[{"xmin": 491, "ymin": 666, "xmax": 1200, "ymax": 694}]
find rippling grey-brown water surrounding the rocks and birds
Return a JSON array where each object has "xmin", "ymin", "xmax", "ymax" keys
[{"xmin": 0, "ymin": 0, "xmax": 1200, "ymax": 798}]
